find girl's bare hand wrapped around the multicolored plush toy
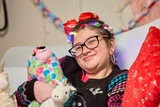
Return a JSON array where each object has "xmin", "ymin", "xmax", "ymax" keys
[{"xmin": 34, "ymin": 81, "xmax": 53, "ymax": 103}]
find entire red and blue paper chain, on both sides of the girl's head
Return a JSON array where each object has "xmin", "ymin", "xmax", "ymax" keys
[{"xmin": 32, "ymin": 0, "xmax": 159, "ymax": 35}]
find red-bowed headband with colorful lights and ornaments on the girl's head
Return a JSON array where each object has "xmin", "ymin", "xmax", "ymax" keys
[{"xmin": 63, "ymin": 12, "xmax": 113, "ymax": 43}]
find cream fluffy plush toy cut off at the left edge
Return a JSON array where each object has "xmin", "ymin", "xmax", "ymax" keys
[{"xmin": 0, "ymin": 61, "xmax": 14, "ymax": 107}]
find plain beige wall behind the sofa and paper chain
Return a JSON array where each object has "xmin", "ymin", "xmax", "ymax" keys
[{"xmin": 0, "ymin": 0, "xmax": 132, "ymax": 59}]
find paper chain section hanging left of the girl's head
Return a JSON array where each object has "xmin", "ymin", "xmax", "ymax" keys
[{"xmin": 32, "ymin": 0, "xmax": 64, "ymax": 32}]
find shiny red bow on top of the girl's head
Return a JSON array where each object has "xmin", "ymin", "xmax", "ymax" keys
[{"xmin": 63, "ymin": 12, "xmax": 99, "ymax": 35}]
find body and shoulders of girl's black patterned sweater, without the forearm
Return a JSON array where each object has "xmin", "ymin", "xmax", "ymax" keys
[{"xmin": 61, "ymin": 56, "xmax": 128, "ymax": 107}]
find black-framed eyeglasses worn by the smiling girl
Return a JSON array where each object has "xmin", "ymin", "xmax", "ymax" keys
[{"xmin": 68, "ymin": 35, "xmax": 107, "ymax": 57}]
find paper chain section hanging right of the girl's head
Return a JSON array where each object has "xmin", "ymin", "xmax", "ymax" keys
[{"xmin": 114, "ymin": 0, "xmax": 158, "ymax": 35}]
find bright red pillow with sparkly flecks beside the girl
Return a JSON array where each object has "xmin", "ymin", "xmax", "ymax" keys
[{"xmin": 122, "ymin": 26, "xmax": 160, "ymax": 107}]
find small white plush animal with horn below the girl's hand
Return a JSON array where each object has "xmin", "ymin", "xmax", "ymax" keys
[{"xmin": 40, "ymin": 80, "xmax": 76, "ymax": 107}]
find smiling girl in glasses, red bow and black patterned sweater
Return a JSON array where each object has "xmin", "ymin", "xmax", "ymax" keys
[{"xmin": 15, "ymin": 12, "xmax": 128, "ymax": 107}]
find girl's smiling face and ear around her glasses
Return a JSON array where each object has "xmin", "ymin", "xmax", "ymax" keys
[{"xmin": 74, "ymin": 28, "xmax": 115, "ymax": 74}]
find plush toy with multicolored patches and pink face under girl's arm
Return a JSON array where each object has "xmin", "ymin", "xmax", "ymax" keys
[{"xmin": 27, "ymin": 46, "xmax": 74, "ymax": 107}]
